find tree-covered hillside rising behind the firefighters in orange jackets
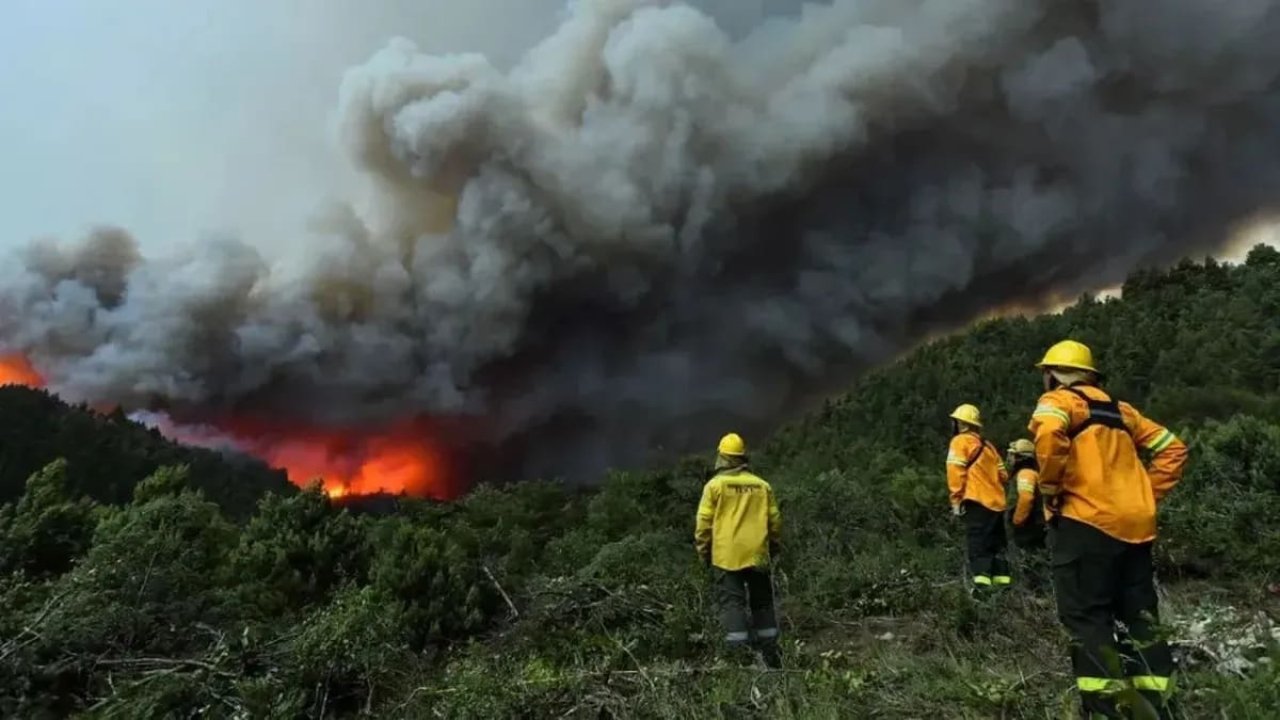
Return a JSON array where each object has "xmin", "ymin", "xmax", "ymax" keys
[{"xmin": 771, "ymin": 246, "xmax": 1280, "ymax": 465}]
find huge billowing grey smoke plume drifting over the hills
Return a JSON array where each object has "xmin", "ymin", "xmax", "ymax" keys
[{"xmin": 0, "ymin": 0, "xmax": 1280, "ymax": 478}]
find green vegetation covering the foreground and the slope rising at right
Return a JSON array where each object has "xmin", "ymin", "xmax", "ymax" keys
[{"xmin": 0, "ymin": 243, "xmax": 1280, "ymax": 720}]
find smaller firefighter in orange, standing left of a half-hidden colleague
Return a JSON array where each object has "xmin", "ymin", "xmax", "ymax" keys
[{"xmin": 947, "ymin": 405, "xmax": 1012, "ymax": 589}]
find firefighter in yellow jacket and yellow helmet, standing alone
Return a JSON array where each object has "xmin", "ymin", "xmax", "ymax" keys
[{"xmin": 694, "ymin": 433, "xmax": 782, "ymax": 667}]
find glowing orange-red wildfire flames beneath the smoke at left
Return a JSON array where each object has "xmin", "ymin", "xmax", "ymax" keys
[{"xmin": 0, "ymin": 355, "xmax": 458, "ymax": 500}]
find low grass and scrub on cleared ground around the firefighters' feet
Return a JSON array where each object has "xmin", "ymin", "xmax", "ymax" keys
[{"xmin": 403, "ymin": 550, "xmax": 1280, "ymax": 720}]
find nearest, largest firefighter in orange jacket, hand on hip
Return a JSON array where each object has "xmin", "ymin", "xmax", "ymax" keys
[{"xmin": 1029, "ymin": 340, "xmax": 1187, "ymax": 717}]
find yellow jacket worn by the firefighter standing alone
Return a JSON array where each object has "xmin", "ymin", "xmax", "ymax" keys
[{"xmin": 694, "ymin": 468, "xmax": 782, "ymax": 570}]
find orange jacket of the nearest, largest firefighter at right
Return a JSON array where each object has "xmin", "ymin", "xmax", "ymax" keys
[{"xmin": 1028, "ymin": 386, "xmax": 1187, "ymax": 543}]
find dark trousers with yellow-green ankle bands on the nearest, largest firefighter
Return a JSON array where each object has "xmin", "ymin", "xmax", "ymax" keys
[{"xmin": 1052, "ymin": 518, "xmax": 1174, "ymax": 719}]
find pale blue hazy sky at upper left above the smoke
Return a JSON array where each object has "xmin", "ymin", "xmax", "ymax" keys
[{"xmin": 0, "ymin": 0, "xmax": 563, "ymax": 256}]
